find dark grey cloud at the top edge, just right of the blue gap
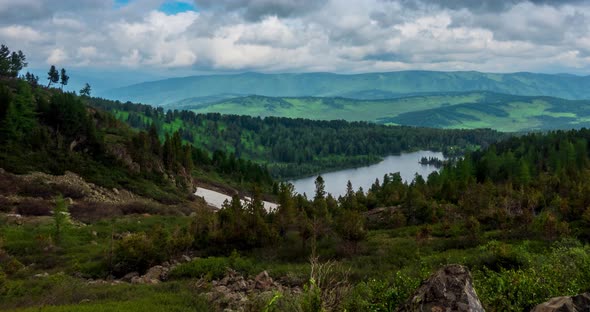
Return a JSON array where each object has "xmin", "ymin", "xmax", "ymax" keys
[{"xmin": 195, "ymin": 0, "xmax": 327, "ymax": 21}]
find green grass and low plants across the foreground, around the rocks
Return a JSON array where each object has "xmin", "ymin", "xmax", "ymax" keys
[{"xmin": 0, "ymin": 215, "xmax": 590, "ymax": 311}]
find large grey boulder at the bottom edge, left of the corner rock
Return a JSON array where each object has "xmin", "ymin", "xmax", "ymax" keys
[{"xmin": 398, "ymin": 264, "xmax": 484, "ymax": 312}]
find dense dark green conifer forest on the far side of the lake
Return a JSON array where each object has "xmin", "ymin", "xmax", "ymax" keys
[{"xmin": 89, "ymin": 98, "xmax": 506, "ymax": 178}]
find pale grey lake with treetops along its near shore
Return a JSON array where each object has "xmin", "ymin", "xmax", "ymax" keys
[{"xmin": 289, "ymin": 151, "xmax": 444, "ymax": 198}]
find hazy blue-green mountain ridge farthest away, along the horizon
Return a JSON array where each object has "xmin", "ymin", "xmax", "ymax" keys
[{"xmin": 100, "ymin": 71, "xmax": 590, "ymax": 105}]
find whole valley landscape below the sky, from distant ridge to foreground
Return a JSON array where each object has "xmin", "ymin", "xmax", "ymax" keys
[{"xmin": 0, "ymin": 39, "xmax": 590, "ymax": 312}]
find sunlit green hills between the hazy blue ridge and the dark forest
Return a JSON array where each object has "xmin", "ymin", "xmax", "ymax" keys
[{"xmin": 177, "ymin": 92, "xmax": 590, "ymax": 131}]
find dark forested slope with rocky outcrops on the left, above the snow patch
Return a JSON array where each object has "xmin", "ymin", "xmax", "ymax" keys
[{"xmin": 0, "ymin": 71, "xmax": 272, "ymax": 202}]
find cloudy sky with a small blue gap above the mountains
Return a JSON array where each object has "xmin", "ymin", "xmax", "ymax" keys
[{"xmin": 0, "ymin": 0, "xmax": 590, "ymax": 88}]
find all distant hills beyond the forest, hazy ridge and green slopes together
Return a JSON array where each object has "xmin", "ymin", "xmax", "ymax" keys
[{"xmin": 104, "ymin": 71, "xmax": 590, "ymax": 131}]
